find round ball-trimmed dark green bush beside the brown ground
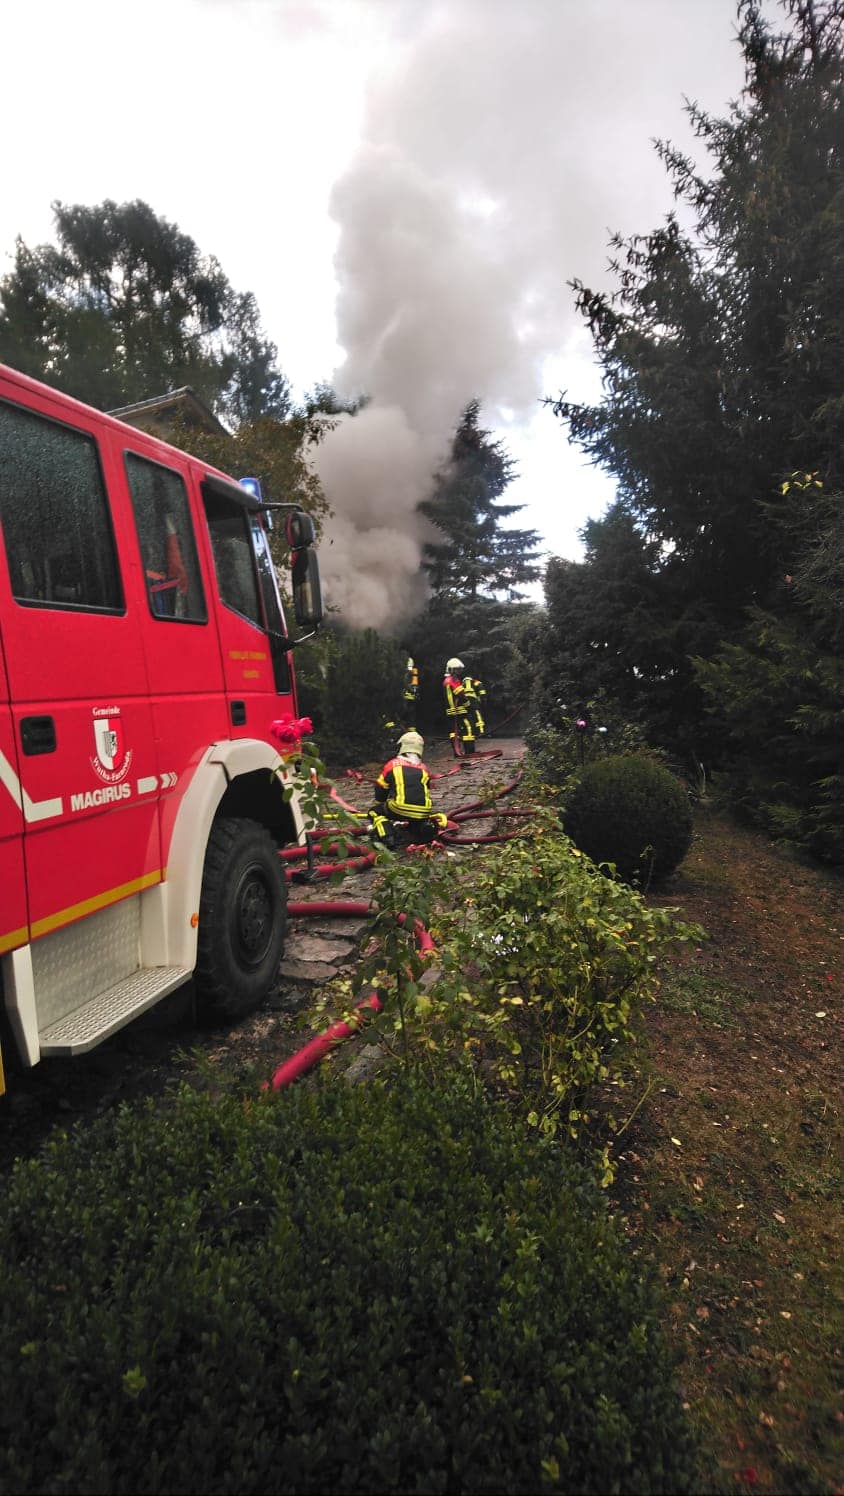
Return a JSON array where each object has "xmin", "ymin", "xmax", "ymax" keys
[{"xmin": 563, "ymin": 754, "xmax": 691, "ymax": 887}]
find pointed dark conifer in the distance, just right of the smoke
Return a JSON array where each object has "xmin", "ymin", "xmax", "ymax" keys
[{"xmin": 419, "ymin": 401, "xmax": 540, "ymax": 600}]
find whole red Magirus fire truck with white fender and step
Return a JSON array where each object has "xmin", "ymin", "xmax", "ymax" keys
[{"xmin": 0, "ymin": 365, "xmax": 322, "ymax": 1088}]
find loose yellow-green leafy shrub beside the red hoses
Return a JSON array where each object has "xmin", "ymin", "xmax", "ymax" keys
[{"xmin": 350, "ymin": 809, "xmax": 700, "ymax": 1142}]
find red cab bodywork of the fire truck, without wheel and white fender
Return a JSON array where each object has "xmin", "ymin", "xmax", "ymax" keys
[{"xmin": 0, "ymin": 365, "xmax": 296, "ymax": 953}]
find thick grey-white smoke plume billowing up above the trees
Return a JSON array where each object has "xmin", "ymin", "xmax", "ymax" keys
[{"xmin": 314, "ymin": 0, "xmax": 735, "ymax": 630}]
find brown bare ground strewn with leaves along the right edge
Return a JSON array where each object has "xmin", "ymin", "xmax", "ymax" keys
[{"xmin": 614, "ymin": 809, "xmax": 844, "ymax": 1492}]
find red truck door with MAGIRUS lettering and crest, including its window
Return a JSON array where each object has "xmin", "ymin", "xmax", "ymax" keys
[{"xmin": 0, "ymin": 396, "xmax": 162, "ymax": 939}]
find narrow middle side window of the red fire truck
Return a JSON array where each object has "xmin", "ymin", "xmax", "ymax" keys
[{"xmin": 126, "ymin": 452, "xmax": 208, "ymax": 624}]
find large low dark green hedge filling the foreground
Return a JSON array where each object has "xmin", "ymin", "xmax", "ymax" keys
[{"xmin": 0, "ymin": 1076, "xmax": 693, "ymax": 1496}]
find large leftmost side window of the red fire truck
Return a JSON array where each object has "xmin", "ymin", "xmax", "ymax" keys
[{"xmin": 0, "ymin": 401, "xmax": 123, "ymax": 613}]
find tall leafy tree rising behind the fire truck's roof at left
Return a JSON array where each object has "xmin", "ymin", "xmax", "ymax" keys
[{"xmin": 0, "ymin": 199, "xmax": 289, "ymax": 423}]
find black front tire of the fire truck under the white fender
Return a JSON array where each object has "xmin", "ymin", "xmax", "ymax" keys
[{"xmin": 195, "ymin": 818, "xmax": 287, "ymax": 1019}]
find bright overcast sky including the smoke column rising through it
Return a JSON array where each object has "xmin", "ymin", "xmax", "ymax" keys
[{"xmin": 0, "ymin": 0, "xmax": 742, "ymax": 624}]
